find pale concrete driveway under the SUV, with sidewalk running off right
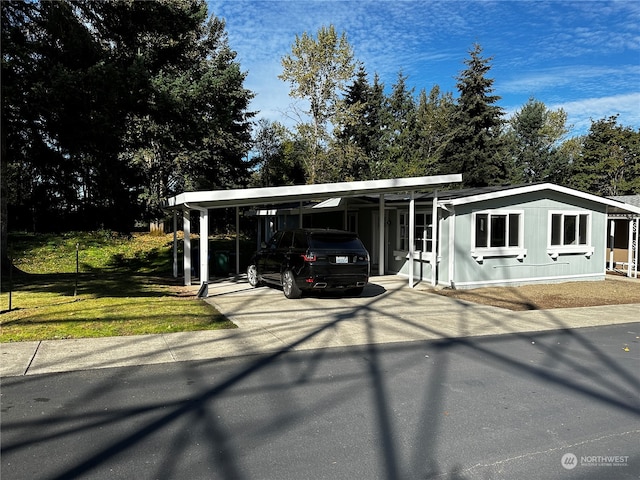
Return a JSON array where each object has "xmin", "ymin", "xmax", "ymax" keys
[{"xmin": 202, "ymin": 276, "xmax": 638, "ymax": 349}]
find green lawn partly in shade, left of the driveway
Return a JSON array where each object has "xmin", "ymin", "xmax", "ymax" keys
[{"xmin": 0, "ymin": 232, "xmax": 250, "ymax": 342}]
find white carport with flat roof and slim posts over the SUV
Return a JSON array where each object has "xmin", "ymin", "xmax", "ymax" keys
[{"xmin": 165, "ymin": 174, "xmax": 462, "ymax": 290}]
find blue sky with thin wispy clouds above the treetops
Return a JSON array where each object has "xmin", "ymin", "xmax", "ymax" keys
[{"xmin": 209, "ymin": 0, "xmax": 640, "ymax": 135}]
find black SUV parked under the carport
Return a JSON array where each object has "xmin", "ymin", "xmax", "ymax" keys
[{"xmin": 247, "ymin": 228, "xmax": 369, "ymax": 298}]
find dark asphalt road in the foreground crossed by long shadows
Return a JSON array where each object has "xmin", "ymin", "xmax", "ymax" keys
[{"xmin": 0, "ymin": 323, "xmax": 640, "ymax": 480}]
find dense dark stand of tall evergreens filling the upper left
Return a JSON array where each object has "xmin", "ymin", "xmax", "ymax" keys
[{"xmin": 1, "ymin": 0, "xmax": 252, "ymax": 232}]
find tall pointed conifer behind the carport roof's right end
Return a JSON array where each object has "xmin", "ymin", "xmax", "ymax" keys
[{"xmin": 440, "ymin": 44, "xmax": 509, "ymax": 187}]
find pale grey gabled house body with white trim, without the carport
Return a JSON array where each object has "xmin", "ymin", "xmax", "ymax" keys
[{"xmin": 256, "ymin": 183, "xmax": 640, "ymax": 288}]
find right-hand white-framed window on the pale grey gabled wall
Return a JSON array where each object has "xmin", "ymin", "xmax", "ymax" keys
[{"xmin": 548, "ymin": 211, "xmax": 593, "ymax": 256}]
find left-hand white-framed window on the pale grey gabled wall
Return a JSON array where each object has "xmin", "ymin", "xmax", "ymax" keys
[{"xmin": 472, "ymin": 210, "xmax": 526, "ymax": 260}]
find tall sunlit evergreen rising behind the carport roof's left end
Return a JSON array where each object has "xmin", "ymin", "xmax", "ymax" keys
[{"xmin": 126, "ymin": 12, "xmax": 253, "ymax": 220}]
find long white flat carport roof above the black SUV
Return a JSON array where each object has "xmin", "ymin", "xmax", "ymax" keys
[{"xmin": 164, "ymin": 174, "xmax": 462, "ymax": 210}]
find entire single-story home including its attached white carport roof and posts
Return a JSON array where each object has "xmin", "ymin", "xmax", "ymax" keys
[{"xmin": 166, "ymin": 178, "xmax": 640, "ymax": 288}]
